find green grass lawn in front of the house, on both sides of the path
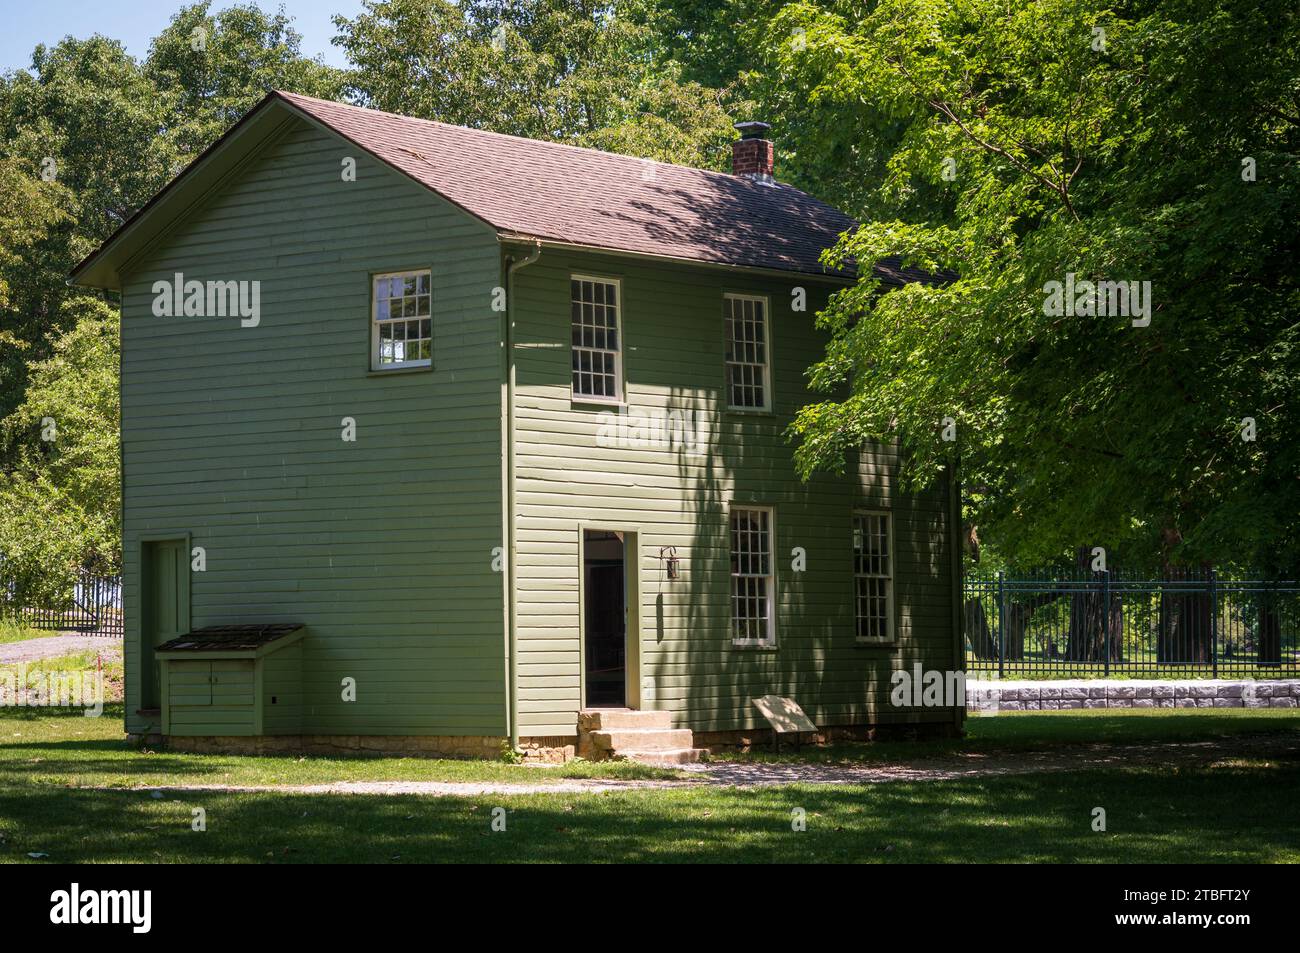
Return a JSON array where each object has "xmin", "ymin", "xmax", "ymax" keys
[{"xmin": 0, "ymin": 710, "xmax": 1300, "ymax": 863}]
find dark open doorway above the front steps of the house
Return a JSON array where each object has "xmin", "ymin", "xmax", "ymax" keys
[{"xmin": 582, "ymin": 529, "xmax": 628, "ymax": 709}]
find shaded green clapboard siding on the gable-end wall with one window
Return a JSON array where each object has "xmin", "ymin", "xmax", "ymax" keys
[{"xmin": 122, "ymin": 121, "xmax": 506, "ymax": 735}]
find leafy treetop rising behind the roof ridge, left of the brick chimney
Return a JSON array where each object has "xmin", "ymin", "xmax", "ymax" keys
[{"xmin": 334, "ymin": 0, "xmax": 735, "ymax": 169}]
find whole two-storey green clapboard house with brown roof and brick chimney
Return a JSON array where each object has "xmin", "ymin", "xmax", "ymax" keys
[{"xmin": 73, "ymin": 92, "xmax": 963, "ymax": 761}]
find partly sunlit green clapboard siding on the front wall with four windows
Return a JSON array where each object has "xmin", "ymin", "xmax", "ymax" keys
[{"xmin": 515, "ymin": 250, "xmax": 957, "ymax": 736}]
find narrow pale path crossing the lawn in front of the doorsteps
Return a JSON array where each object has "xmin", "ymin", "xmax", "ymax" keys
[{"xmin": 106, "ymin": 735, "xmax": 1300, "ymax": 797}]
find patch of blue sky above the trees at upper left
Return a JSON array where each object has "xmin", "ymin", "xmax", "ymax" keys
[{"xmin": 0, "ymin": 0, "xmax": 361, "ymax": 72}]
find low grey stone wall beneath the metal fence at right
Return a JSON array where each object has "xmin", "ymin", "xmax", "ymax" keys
[{"xmin": 966, "ymin": 679, "xmax": 1300, "ymax": 712}]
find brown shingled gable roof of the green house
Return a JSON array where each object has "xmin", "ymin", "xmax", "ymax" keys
[{"xmin": 73, "ymin": 91, "xmax": 927, "ymax": 286}]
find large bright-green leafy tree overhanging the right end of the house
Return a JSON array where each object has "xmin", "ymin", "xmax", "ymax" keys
[{"xmin": 764, "ymin": 0, "xmax": 1300, "ymax": 573}]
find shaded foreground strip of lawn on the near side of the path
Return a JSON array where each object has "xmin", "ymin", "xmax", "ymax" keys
[{"xmin": 0, "ymin": 764, "xmax": 1300, "ymax": 863}]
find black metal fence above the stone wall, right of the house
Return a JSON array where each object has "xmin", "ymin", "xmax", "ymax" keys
[{"xmin": 962, "ymin": 572, "xmax": 1300, "ymax": 679}]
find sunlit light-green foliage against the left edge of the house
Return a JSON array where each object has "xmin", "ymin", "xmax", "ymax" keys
[{"xmin": 0, "ymin": 298, "xmax": 121, "ymax": 597}]
